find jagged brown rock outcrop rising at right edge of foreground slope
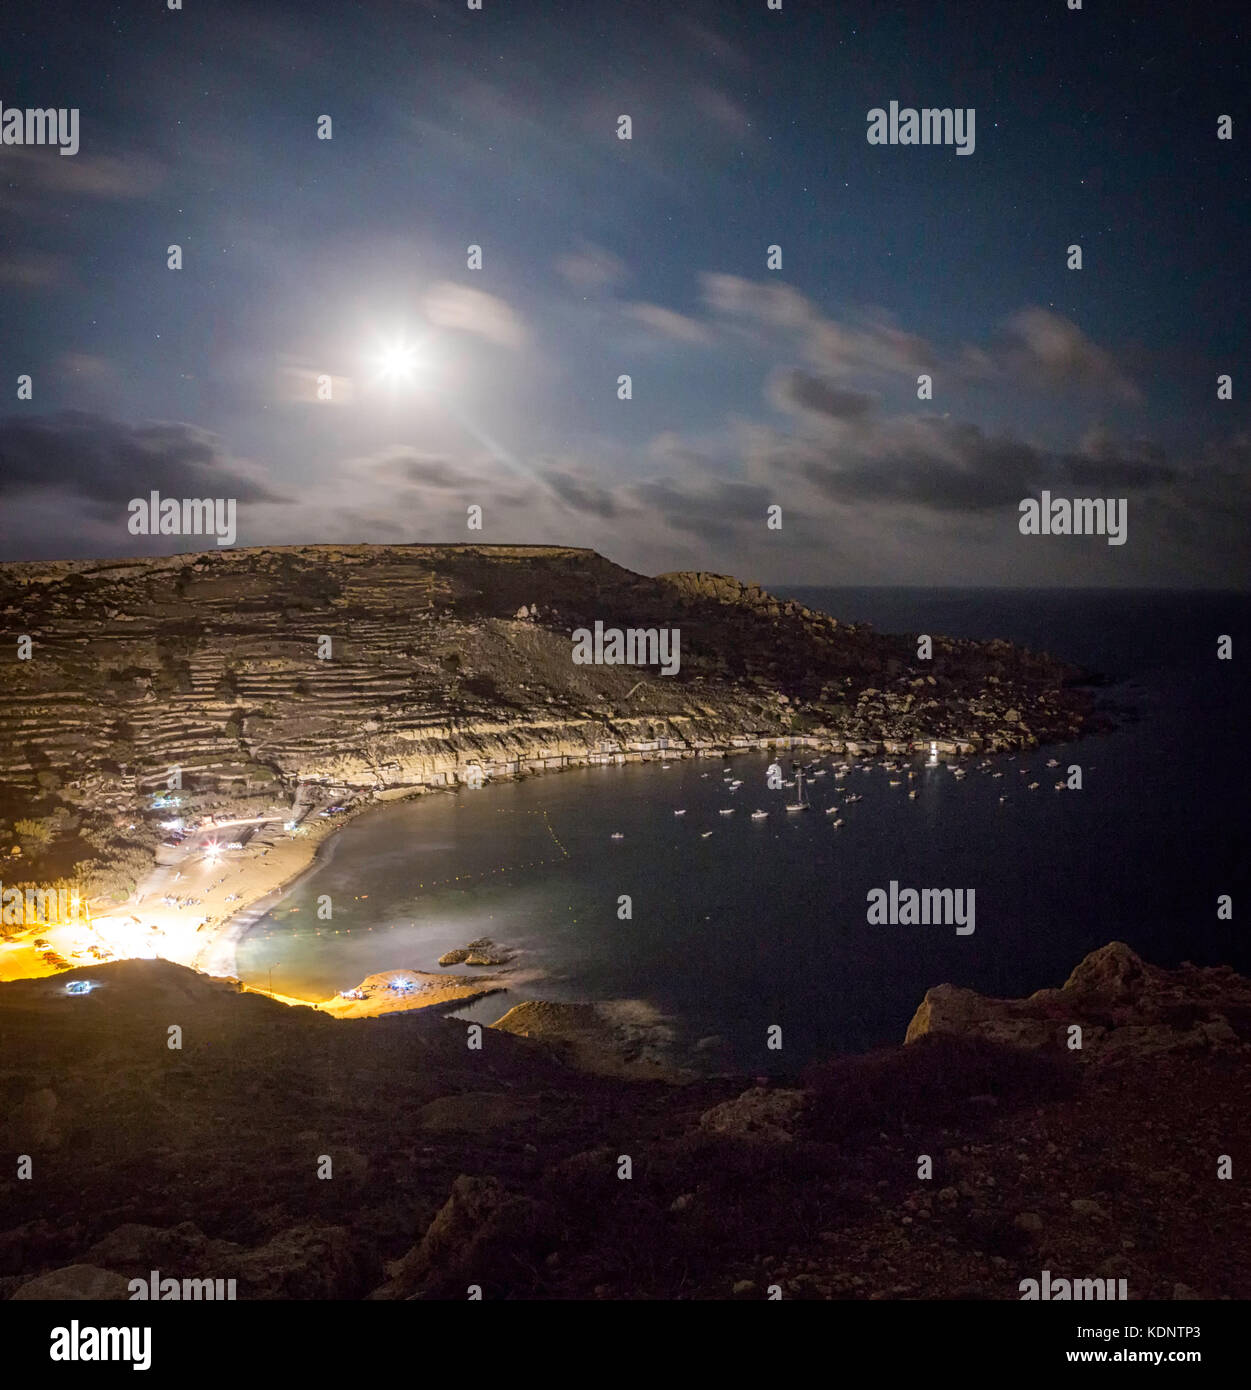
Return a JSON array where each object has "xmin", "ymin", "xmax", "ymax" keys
[{"xmin": 905, "ymin": 941, "xmax": 1251, "ymax": 1065}]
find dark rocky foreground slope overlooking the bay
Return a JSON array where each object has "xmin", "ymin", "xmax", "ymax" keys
[{"xmin": 0, "ymin": 944, "xmax": 1251, "ymax": 1300}]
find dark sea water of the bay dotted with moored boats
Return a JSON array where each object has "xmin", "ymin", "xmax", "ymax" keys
[{"xmin": 239, "ymin": 589, "xmax": 1251, "ymax": 1072}]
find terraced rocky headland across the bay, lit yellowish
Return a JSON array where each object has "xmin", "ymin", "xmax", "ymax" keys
[{"xmin": 0, "ymin": 545, "xmax": 1087, "ymax": 895}]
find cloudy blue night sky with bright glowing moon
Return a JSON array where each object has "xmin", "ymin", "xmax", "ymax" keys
[{"xmin": 0, "ymin": 0, "xmax": 1251, "ymax": 588}]
